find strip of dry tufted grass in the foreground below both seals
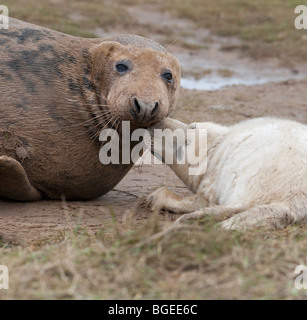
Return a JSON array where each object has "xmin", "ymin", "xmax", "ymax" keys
[{"xmin": 0, "ymin": 212, "xmax": 307, "ymax": 299}]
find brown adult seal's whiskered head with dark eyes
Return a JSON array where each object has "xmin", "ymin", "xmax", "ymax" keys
[{"xmin": 90, "ymin": 35, "xmax": 180, "ymax": 127}]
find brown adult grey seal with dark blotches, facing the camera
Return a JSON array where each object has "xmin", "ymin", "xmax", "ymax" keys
[{"xmin": 0, "ymin": 19, "xmax": 180, "ymax": 201}]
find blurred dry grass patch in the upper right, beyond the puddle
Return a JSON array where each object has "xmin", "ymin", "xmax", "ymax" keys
[{"xmin": 163, "ymin": 0, "xmax": 307, "ymax": 63}]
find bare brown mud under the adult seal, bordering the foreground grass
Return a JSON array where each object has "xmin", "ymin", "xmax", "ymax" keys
[{"xmin": 0, "ymin": 165, "xmax": 188, "ymax": 245}]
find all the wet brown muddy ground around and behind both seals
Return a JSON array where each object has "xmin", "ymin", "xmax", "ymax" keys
[{"xmin": 0, "ymin": 4, "xmax": 307, "ymax": 244}]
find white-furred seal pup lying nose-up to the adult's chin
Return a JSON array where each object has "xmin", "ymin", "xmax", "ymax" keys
[{"xmin": 145, "ymin": 118, "xmax": 307, "ymax": 230}]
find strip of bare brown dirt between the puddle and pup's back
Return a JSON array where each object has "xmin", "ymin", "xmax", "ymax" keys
[{"xmin": 176, "ymin": 80, "xmax": 307, "ymax": 125}]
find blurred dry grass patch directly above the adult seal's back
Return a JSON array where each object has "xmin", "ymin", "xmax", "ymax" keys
[{"xmin": 6, "ymin": 0, "xmax": 132, "ymax": 37}]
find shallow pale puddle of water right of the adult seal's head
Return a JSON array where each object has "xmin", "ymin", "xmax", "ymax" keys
[{"xmin": 177, "ymin": 52, "xmax": 307, "ymax": 90}]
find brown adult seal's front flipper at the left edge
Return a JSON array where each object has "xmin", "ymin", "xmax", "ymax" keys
[{"xmin": 0, "ymin": 156, "xmax": 43, "ymax": 201}]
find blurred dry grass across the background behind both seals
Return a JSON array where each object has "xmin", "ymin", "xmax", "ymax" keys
[{"xmin": 6, "ymin": 0, "xmax": 307, "ymax": 65}]
